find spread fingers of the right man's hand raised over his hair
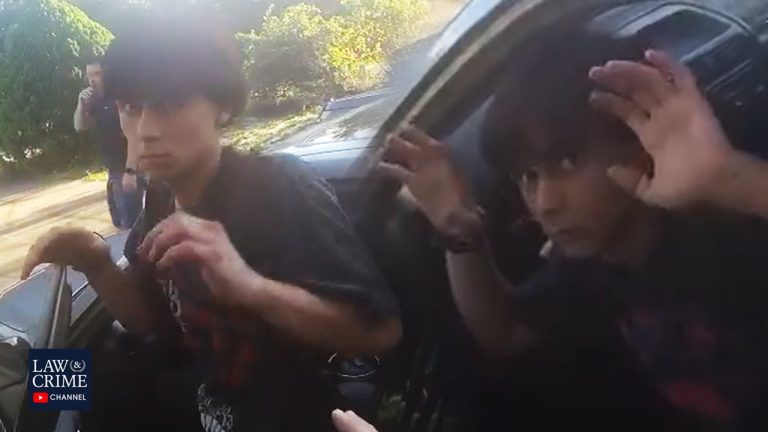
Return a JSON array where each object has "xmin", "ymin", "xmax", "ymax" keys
[{"xmin": 589, "ymin": 61, "xmax": 674, "ymax": 111}]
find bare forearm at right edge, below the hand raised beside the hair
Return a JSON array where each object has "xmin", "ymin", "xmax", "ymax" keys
[{"xmin": 710, "ymin": 153, "xmax": 768, "ymax": 219}]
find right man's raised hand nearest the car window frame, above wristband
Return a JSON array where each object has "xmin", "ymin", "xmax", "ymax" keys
[{"xmin": 380, "ymin": 126, "xmax": 476, "ymax": 236}]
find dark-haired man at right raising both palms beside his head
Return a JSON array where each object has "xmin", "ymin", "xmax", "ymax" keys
[{"xmin": 382, "ymin": 29, "xmax": 768, "ymax": 430}]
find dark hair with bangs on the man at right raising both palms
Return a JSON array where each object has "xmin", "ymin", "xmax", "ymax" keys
[{"xmin": 481, "ymin": 23, "xmax": 643, "ymax": 174}]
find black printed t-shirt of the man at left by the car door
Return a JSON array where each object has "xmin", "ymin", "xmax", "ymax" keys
[{"xmin": 125, "ymin": 149, "xmax": 398, "ymax": 431}]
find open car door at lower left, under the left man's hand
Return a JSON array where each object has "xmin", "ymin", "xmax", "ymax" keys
[{"xmin": 0, "ymin": 234, "xmax": 126, "ymax": 432}]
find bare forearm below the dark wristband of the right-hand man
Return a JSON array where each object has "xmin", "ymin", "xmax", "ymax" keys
[{"xmin": 446, "ymin": 246, "xmax": 533, "ymax": 357}]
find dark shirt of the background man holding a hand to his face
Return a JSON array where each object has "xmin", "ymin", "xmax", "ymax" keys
[{"xmin": 88, "ymin": 95, "xmax": 128, "ymax": 172}]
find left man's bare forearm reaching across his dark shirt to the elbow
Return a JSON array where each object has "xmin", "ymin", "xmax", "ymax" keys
[{"xmin": 232, "ymin": 276, "xmax": 401, "ymax": 356}]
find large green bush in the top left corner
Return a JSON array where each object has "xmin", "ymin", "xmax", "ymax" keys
[{"xmin": 0, "ymin": 0, "xmax": 112, "ymax": 169}]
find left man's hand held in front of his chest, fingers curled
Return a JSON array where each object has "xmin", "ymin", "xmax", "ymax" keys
[{"xmin": 138, "ymin": 211, "xmax": 261, "ymax": 305}]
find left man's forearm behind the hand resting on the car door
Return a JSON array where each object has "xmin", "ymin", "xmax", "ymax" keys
[{"xmin": 87, "ymin": 264, "xmax": 154, "ymax": 335}]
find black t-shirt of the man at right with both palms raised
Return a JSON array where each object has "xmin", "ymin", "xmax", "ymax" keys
[{"xmin": 511, "ymin": 215, "xmax": 768, "ymax": 430}]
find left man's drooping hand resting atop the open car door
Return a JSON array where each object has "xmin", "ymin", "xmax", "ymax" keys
[{"xmin": 21, "ymin": 227, "xmax": 112, "ymax": 280}]
